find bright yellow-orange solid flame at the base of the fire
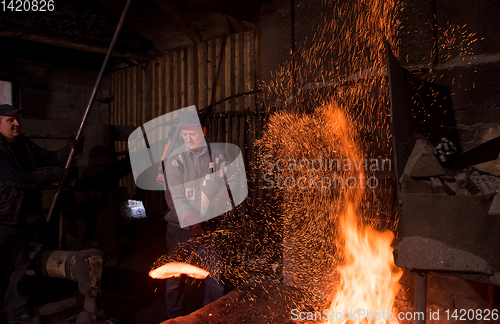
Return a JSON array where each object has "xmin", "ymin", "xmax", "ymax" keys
[{"xmin": 330, "ymin": 203, "xmax": 402, "ymax": 323}]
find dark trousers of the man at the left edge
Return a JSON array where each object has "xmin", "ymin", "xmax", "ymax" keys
[{"xmin": 0, "ymin": 225, "xmax": 29, "ymax": 316}]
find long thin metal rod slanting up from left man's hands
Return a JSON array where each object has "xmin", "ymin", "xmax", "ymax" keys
[{"xmin": 47, "ymin": 0, "xmax": 132, "ymax": 222}]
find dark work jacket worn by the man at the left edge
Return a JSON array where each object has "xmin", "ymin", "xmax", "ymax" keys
[{"xmin": 0, "ymin": 135, "xmax": 61, "ymax": 225}]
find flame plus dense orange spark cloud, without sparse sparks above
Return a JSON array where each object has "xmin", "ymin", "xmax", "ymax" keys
[{"xmin": 259, "ymin": 101, "xmax": 402, "ymax": 324}]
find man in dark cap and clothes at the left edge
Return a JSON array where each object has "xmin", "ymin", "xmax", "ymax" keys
[{"xmin": 0, "ymin": 104, "xmax": 79, "ymax": 324}]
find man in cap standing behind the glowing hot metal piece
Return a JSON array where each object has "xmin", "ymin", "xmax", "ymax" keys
[{"xmin": 165, "ymin": 111, "xmax": 236, "ymax": 318}]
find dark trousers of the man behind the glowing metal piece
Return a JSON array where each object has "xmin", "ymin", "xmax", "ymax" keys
[{"xmin": 165, "ymin": 224, "xmax": 224, "ymax": 318}]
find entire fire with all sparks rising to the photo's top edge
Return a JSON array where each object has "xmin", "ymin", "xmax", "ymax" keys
[{"xmin": 259, "ymin": 0, "xmax": 402, "ymax": 316}]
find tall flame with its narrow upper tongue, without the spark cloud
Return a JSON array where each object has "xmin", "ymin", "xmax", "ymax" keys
[{"xmin": 324, "ymin": 105, "xmax": 402, "ymax": 323}]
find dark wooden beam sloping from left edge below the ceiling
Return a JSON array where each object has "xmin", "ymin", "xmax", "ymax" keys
[{"xmin": 0, "ymin": 30, "xmax": 152, "ymax": 61}]
